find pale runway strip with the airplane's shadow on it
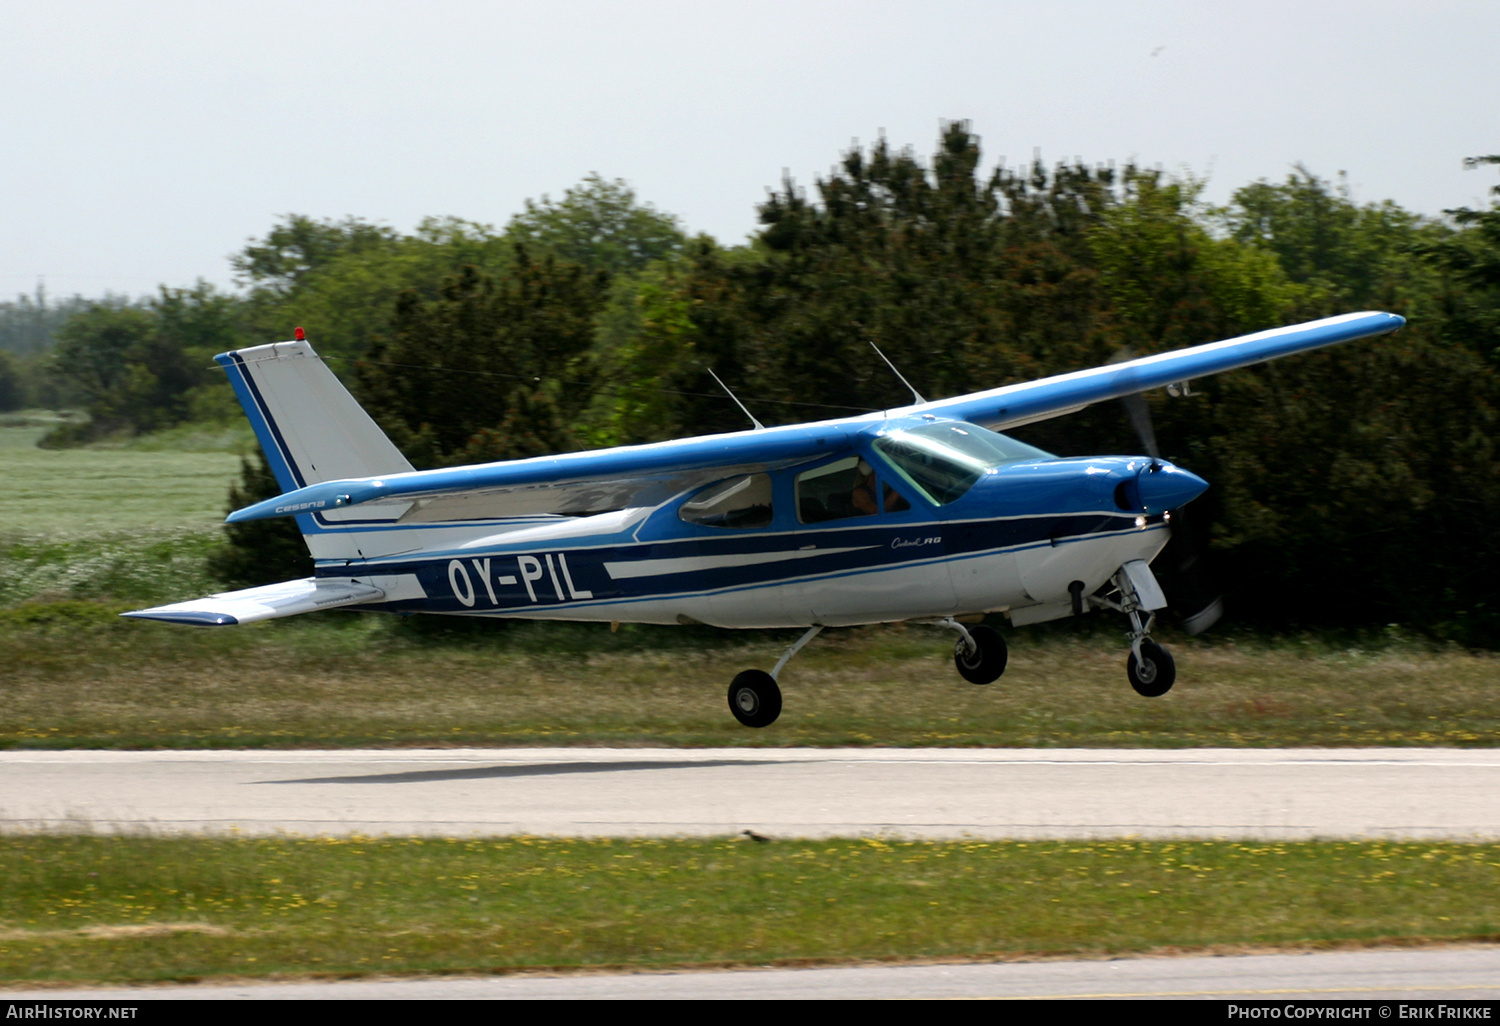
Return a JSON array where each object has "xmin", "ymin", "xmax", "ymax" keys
[{"xmin": 0, "ymin": 749, "xmax": 1500, "ymax": 840}]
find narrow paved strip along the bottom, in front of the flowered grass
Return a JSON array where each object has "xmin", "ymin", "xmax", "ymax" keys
[{"xmin": 0, "ymin": 947, "xmax": 1500, "ymax": 1002}]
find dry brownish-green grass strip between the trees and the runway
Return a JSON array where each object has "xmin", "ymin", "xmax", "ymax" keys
[{"xmin": 0, "ymin": 606, "xmax": 1500, "ymax": 749}]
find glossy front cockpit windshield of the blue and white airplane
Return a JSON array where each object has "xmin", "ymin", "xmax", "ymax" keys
[{"xmin": 875, "ymin": 422, "xmax": 1056, "ymax": 506}]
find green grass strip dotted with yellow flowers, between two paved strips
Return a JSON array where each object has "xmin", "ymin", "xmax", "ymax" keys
[{"xmin": 0, "ymin": 836, "xmax": 1500, "ymax": 983}]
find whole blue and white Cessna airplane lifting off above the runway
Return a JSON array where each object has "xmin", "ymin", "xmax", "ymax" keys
[{"xmin": 123, "ymin": 312, "xmax": 1406, "ymax": 728}]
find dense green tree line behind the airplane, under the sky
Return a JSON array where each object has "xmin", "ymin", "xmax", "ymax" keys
[{"xmin": 26, "ymin": 123, "xmax": 1500, "ymax": 645}]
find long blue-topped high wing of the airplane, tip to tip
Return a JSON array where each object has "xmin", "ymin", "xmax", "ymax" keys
[{"xmin": 228, "ymin": 312, "xmax": 1406, "ymax": 524}]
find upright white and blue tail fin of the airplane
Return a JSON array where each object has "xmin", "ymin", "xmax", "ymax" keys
[{"xmin": 215, "ymin": 339, "xmax": 413, "ymax": 560}]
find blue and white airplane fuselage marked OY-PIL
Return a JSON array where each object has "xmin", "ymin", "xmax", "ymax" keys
[{"xmin": 318, "ymin": 444, "xmax": 1206, "ymax": 627}]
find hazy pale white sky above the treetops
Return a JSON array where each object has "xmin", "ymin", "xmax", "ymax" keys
[{"xmin": 0, "ymin": 0, "xmax": 1500, "ymax": 297}]
